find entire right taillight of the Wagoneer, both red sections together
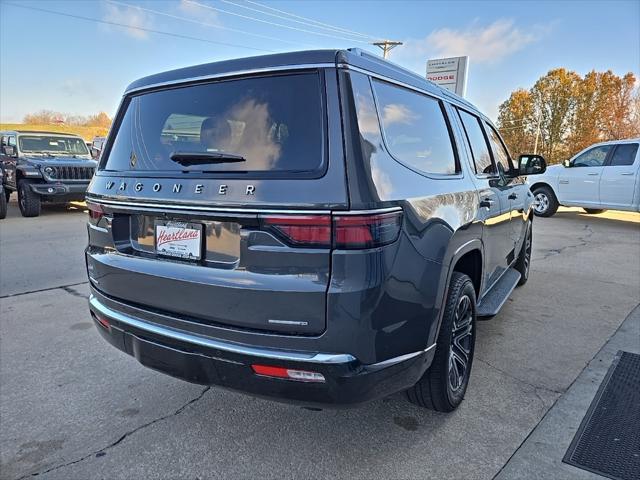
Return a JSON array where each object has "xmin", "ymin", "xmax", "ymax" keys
[{"xmin": 261, "ymin": 210, "xmax": 402, "ymax": 249}]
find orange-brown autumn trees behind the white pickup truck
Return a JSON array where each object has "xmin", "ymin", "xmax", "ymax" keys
[{"xmin": 498, "ymin": 68, "xmax": 640, "ymax": 164}]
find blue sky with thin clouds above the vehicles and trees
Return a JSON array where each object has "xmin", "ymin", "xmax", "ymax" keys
[{"xmin": 0, "ymin": 0, "xmax": 640, "ymax": 122}]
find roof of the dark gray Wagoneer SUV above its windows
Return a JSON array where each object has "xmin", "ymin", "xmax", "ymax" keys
[{"xmin": 125, "ymin": 48, "xmax": 477, "ymax": 111}]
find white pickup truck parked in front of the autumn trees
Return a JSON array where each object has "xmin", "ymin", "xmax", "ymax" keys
[{"xmin": 530, "ymin": 138, "xmax": 640, "ymax": 217}]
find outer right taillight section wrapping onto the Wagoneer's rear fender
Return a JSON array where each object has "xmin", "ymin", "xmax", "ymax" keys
[{"xmin": 333, "ymin": 211, "xmax": 402, "ymax": 249}]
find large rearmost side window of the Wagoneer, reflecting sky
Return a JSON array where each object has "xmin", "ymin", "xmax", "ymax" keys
[{"xmin": 373, "ymin": 80, "xmax": 458, "ymax": 175}]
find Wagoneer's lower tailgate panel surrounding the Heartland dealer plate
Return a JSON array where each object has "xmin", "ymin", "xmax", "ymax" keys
[{"xmin": 87, "ymin": 213, "xmax": 330, "ymax": 335}]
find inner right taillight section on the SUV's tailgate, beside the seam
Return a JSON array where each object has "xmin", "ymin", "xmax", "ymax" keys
[{"xmin": 262, "ymin": 215, "xmax": 331, "ymax": 247}]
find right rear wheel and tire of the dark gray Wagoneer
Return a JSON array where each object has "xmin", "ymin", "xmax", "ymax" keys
[{"xmin": 407, "ymin": 272, "xmax": 476, "ymax": 412}]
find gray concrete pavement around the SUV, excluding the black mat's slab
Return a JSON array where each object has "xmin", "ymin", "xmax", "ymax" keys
[{"xmin": 0, "ymin": 196, "xmax": 640, "ymax": 479}]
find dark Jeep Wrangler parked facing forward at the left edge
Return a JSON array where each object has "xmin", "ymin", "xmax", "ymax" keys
[{"xmin": 0, "ymin": 131, "xmax": 97, "ymax": 217}]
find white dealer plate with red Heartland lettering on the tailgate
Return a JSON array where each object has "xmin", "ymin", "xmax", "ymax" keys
[{"xmin": 155, "ymin": 221, "xmax": 202, "ymax": 260}]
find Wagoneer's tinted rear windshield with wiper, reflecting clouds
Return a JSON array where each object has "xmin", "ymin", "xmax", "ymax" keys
[{"xmin": 103, "ymin": 72, "xmax": 324, "ymax": 175}]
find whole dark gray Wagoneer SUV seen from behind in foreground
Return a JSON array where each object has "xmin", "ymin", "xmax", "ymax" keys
[{"xmin": 86, "ymin": 50, "xmax": 546, "ymax": 411}]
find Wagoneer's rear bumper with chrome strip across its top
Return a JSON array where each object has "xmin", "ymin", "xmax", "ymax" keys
[{"xmin": 89, "ymin": 295, "xmax": 435, "ymax": 406}]
